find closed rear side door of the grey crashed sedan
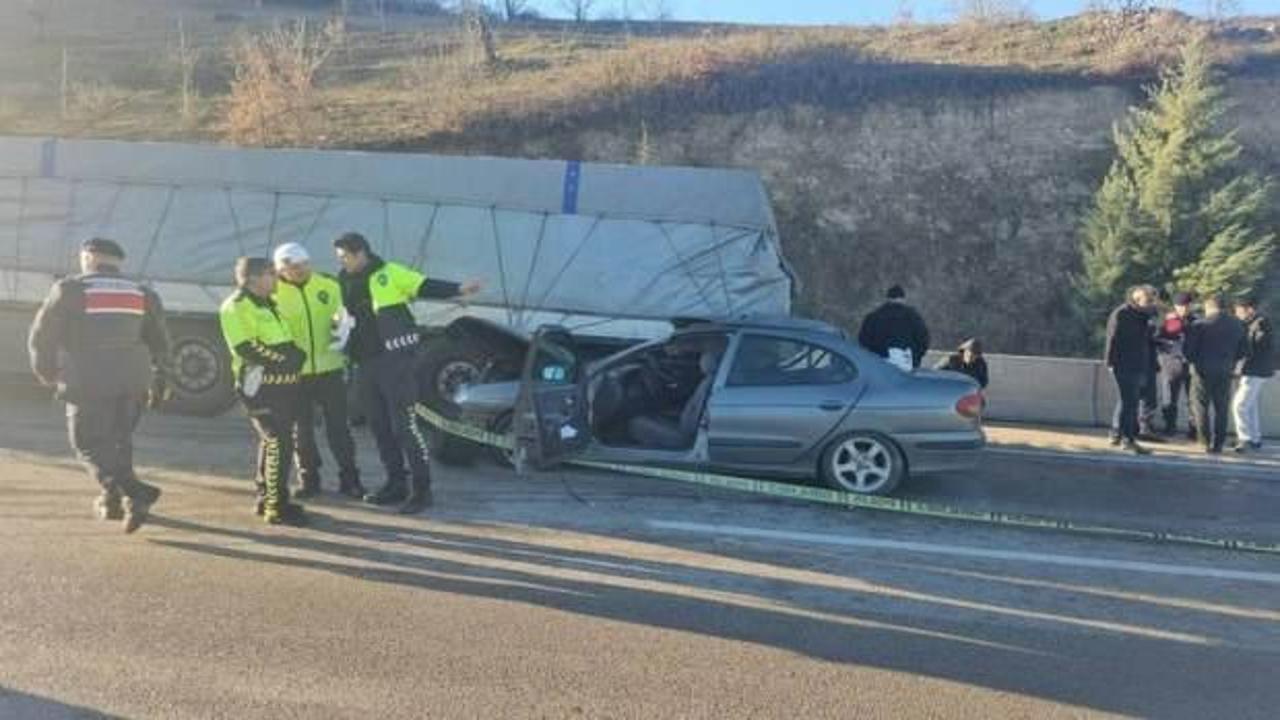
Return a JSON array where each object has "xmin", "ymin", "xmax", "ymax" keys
[{"xmin": 708, "ymin": 332, "xmax": 865, "ymax": 466}]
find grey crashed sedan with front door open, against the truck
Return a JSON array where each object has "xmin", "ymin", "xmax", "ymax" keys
[{"xmin": 453, "ymin": 318, "xmax": 986, "ymax": 495}]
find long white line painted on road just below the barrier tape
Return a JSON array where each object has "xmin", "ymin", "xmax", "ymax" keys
[{"xmin": 645, "ymin": 520, "xmax": 1280, "ymax": 585}]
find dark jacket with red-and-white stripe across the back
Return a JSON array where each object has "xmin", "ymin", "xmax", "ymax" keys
[{"xmin": 27, "ymin": 268, "xmax": 169, "ymax": 404}]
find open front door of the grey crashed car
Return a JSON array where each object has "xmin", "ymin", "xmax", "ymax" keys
[{"xmin": 512, "ymin": 325, "xmax": 591, "ymax": 471}]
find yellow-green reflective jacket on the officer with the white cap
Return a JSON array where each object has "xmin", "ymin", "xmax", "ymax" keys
[{"xmin": 273, "ymin": 273, "xmax": 347, "ymax": 375}]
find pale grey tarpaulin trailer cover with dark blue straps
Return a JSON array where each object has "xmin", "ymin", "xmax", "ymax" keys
[{"xmin": 0, "ymin": 137, "xmax": 792, "ymax": 324}]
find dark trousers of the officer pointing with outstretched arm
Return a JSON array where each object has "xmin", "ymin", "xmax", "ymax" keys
[{"xmin": 356, "ymin": 350, "xmax": 431, "ymax": 489}]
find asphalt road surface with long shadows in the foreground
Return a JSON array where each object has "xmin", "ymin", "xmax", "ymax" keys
[{"xmin": 0, "ymin": 389, "xmax": 1280, "ymax": 719}]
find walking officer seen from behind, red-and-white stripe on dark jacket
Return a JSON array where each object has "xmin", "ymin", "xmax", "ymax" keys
[{"xmin": 28, "ymin": 238, "xmax": 169, "ymax": 533}]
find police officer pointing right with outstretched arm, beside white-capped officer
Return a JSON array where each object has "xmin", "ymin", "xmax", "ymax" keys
[{"xmin": 333, "ymin": 233, "xmax": 480, "ymax": 514}]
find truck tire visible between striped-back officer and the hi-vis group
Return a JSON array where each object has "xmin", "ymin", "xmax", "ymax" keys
[{"xmin": 164, "ymin": 319, "xmax": 236, "ymax": 418}]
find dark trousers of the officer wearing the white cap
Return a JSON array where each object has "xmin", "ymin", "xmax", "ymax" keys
[{"xmin": 293, "ymin": 370, "xmax": 360, "ymax": 487}]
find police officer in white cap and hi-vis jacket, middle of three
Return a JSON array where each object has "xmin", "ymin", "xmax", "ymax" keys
[{"xmin": 271, "ymin": 242, "xmax": 365, "ymax": 500}]
